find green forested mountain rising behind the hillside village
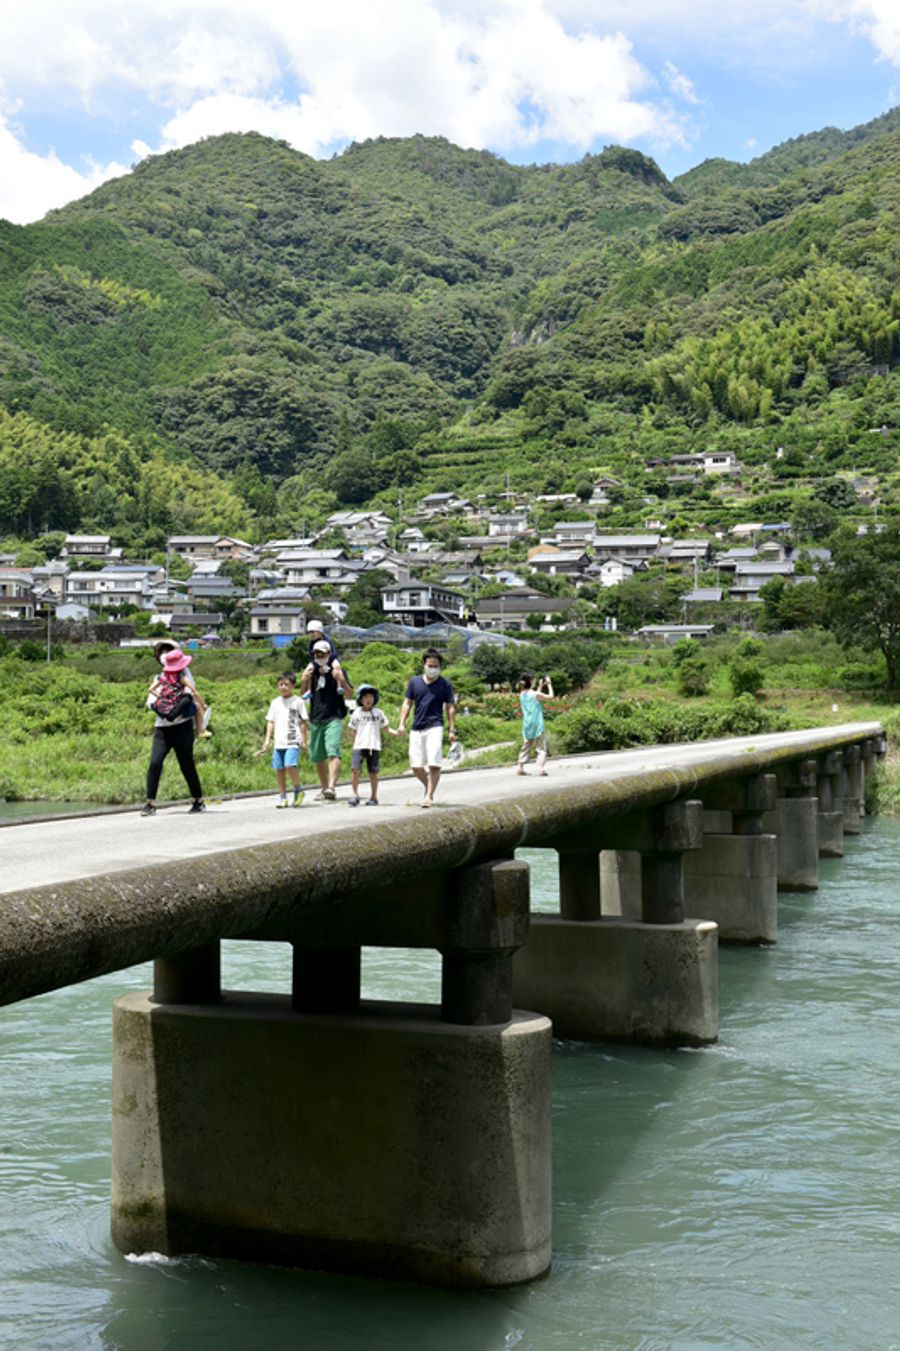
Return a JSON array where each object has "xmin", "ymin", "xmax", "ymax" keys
[{"xmin": 0, "ymin": 112, "xmax": 900, "ymax": 544}]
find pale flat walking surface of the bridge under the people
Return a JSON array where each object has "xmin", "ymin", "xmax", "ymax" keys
[{"xmin": 0, "ymin": 723, "xmax": 880, "ymax": 894}]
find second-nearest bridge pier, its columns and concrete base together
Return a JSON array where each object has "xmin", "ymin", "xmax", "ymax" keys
[{"xmin": 512, "ymin": 801, "xmax": 719, "ymax": 1046}]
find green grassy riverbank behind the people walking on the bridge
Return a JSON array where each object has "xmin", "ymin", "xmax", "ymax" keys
[{"xmin": 0, "ymin": 634, "xmax": 900, "ymax": 812}]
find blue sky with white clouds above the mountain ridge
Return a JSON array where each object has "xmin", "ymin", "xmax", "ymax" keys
[{"xmin": 0, "ymin": 0, "xmax": 900, "ymax": 223}]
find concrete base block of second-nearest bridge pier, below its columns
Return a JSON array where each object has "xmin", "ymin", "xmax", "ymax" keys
[{"xmin": 512, "ymin": 915, "xmax": 719, "ymax": 1046}]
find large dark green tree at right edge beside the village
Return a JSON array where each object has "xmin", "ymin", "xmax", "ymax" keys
[{"xmin": 820, "ymin": 523, "xmax": 900, "ymax": 694}]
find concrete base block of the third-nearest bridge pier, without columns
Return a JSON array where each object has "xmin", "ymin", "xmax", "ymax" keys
[{"xmin": 684, "ymin": 835, "xmax": 778, "ymax": 943}]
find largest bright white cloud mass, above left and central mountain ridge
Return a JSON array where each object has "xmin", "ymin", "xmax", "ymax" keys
[{"xmin": 0, "ymin": 0, "xmax": 692, "ymax": 211}]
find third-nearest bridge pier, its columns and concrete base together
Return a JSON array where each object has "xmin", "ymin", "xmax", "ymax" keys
[{"xmin": 684, "ymin": 774, "xmax": 778, "ymax": 943}]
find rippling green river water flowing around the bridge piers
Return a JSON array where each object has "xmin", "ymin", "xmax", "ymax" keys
[{"xmin": 0, "ymin": 820, "xmax": 900, "ymax": 1351}]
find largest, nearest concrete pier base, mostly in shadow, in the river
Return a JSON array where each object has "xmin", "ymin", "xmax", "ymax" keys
[{"xmin": 112, "ymin": 994, "xmax": 550, "ymax": 1288}]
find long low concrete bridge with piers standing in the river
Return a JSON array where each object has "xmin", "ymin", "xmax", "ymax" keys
[{"xmin": 0, "ymin": 723, "xmax": 885, "ymax": 1288}]
